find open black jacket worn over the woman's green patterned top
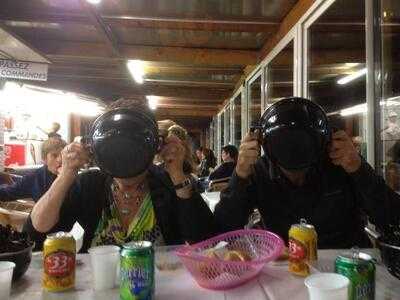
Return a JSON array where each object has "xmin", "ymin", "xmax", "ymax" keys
[{"xmin": 24, "ymin": 166, "xmax": 214, "ymax": 252}]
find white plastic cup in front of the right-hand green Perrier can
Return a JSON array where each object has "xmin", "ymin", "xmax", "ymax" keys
[{"xmin": 304, "ymin": 273, "xmax": 350, "ymax": 300}]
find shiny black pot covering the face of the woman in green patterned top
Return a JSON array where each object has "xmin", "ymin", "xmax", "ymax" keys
[{"xmin": 89, "ymin": 106, "xmax": 159, "ymax": 178}]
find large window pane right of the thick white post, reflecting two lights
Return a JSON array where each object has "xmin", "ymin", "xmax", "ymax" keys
[{"xmin": 307, "ymin": 0, "xmax": 367, "ymax": 158}]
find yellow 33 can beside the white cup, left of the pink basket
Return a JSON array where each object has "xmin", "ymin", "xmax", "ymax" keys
[{"xmin": 42, "ymin": 232, "xmax": 76, "ymax": 292}]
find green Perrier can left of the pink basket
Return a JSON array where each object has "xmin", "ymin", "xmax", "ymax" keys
[{"xmin": 119, "ymin": 241, "xmax": 154, "ymax": 300}]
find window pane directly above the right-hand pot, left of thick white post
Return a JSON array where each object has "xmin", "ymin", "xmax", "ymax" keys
[{"xmin": 265, "ymin": 41, "xmax": 294, "ymax": 106}]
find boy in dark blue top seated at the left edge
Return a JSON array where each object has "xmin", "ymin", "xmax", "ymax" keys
[{"xmin": 0, "ymin": 138, "xmax": 67, "ymax": 202}]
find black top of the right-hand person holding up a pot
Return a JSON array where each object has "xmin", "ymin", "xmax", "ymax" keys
[{"xmin": 215, "ymin": 157, "xmax": 400, "ymax": 248}]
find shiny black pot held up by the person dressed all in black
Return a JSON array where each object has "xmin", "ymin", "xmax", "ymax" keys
[{"xmin": 259, "ymin": 97, "xmax": 331, "ymax": 170}]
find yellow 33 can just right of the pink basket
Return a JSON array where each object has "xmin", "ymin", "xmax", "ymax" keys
[{"xmin": 289, "ymin": 219, "xmax": 318, "ymax": 276}]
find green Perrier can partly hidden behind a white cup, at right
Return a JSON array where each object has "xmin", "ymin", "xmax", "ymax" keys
[{"xmin": 335, "ymin": 250, "xmax": 375, "ymax": 300}]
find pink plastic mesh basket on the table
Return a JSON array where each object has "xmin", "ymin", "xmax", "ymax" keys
[{"xmin": 176, "ymin": 229, "xmax": 284, "ymax": 290}]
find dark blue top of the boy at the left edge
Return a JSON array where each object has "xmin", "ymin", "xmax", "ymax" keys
[{"xmin": 0, "ymin": 165, "xmax": 56, "ymax": 202}]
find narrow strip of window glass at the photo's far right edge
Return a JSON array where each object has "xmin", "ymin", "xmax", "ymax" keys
[{"xmin": 380, "ymin": 0, "xmax": 400, "ymax": 191}]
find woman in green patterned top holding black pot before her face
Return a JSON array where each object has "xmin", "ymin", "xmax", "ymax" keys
[{"xmin": 24, "ymin": 100, "xmax": 214, "ymax": 251}]
